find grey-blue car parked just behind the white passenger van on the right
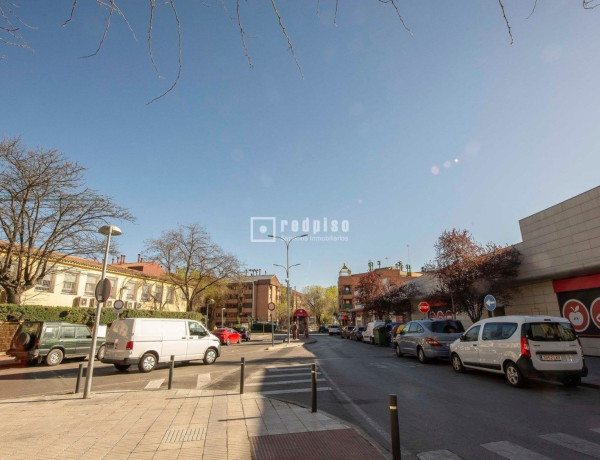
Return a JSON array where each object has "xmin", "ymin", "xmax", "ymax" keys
[{"xmin": 395, "ymin": 319, "xmax": 465, "ymax": 363}]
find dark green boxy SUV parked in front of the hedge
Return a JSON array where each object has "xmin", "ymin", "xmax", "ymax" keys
[{"xmin": 7, "ymin": 321, "xmax": 105, "ymax": 366}]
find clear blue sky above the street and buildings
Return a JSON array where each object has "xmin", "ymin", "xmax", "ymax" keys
[{"xmin": 0, "ymin": 0, "xmax": 600, "ymax": 288}]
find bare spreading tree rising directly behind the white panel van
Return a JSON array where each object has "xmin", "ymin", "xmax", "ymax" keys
[{"xmin": 146, "ymin": 224, "xmax": 240, "ymax": 311}]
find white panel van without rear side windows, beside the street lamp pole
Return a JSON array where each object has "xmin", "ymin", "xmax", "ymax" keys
[{"xmin": 102, "ymin": 318, "xmax": 221, "ymax": 372}]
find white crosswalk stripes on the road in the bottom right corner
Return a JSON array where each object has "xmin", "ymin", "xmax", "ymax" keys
[{"xmin": 412, "ymin": 427, "xmax": 600, "ymax": 460}]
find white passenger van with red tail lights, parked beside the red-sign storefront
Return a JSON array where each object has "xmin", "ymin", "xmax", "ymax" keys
[{"xmin": 450, "ymin": 316, "xmax": 588, "ymax": 387}]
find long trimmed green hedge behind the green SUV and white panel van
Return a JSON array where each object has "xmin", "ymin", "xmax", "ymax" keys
[{"xmin": 0, "ymin": 304, "xmax": 204, "ymax": 326}]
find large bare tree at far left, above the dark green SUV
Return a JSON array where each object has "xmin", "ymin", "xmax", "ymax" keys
[{"xmin": 0, "ymin": 138, "xmax": 134, "ymax": 304}]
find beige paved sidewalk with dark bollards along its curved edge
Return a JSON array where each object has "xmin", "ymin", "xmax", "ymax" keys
[{"xmin": 0, "ymin": 390, "xmax": 386, "ymax": 460}]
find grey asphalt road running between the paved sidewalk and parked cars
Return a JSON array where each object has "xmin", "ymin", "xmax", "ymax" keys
[{"xmin": 0, "ymin": 335, "xmax": 600, "ymax": 460}]
